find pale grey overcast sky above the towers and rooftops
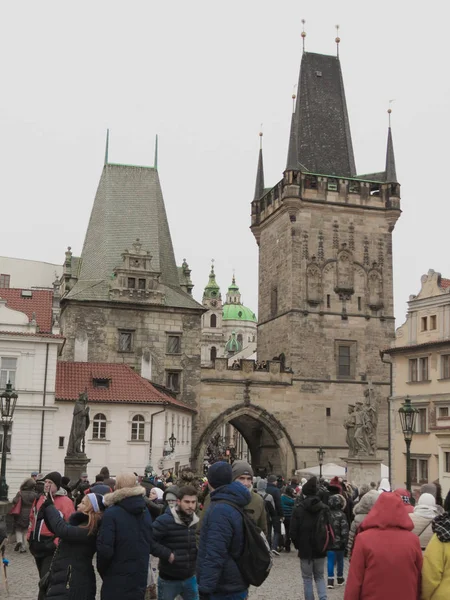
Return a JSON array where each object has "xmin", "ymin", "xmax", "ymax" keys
[{"xmin": 0, "ymin": 0, "xmax": 450, "ymax": 326}]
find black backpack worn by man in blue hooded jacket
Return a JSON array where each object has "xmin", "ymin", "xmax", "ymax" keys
[{"xmin": 219, "ymin": 500, "xmax": 273, "ymax": 587}]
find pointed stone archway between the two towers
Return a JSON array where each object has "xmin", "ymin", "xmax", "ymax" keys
[{"xmin": 192, "ymin": 404, "xmax": 297, "ymax": 476}]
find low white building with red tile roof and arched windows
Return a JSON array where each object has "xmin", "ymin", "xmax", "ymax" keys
[{"xmin": 54, "ymin": 362, "xmax": 195, "ymax": 481}]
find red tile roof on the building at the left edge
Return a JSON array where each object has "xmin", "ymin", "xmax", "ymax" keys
[{"xmin": 0, "ymin": 288, "xmax": 53, "ymax": 333}]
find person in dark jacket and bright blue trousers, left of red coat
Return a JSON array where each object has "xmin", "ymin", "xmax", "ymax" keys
[{"xmin": 327, "ymin": 494, "xmax": 348, "ymax": 589}]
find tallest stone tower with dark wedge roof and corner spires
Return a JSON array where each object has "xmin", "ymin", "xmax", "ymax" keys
[{"xmin": 251, "ymin": 52, "xmax": 401, "ymax": 408}]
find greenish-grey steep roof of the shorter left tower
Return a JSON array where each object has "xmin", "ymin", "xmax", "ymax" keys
[{"xmin": 67, "ymin": 163, "xmax": 199, "ymax": 308}]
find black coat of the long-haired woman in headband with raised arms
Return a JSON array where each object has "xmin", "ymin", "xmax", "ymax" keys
[{"xmin": 44, "ymin": 506, "xmax": 97, "ymax": 600}]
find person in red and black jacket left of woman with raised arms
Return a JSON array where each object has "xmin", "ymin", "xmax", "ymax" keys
[{"xmin": 28, "ymin": 471, "xmax": 75, "ymax": 600}]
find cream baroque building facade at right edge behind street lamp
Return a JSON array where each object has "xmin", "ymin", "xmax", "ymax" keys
[{"xmin": 386, "ymin": 269, "xmax": 450, "ymax": 497}]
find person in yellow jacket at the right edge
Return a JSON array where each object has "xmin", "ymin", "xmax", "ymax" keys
[{"xmin": 422, "ymin": 512, "xmax": 450, "ymax": 600}]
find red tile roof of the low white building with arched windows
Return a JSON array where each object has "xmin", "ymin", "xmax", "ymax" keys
[{"xmin": 55, "ymin": 361, "xmax": 195, "ymax": 412}]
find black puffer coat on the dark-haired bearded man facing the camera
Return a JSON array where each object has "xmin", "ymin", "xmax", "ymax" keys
[{"xmin": 152, "ymin": 508, "xmax": 200, "ymax": 580}]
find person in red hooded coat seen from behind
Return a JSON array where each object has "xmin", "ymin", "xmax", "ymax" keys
[{"xmin": 344, "ymin": 493, "xmax": 422, "ymax": 600}]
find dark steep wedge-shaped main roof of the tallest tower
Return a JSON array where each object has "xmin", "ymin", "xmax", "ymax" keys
[{"xmin": 291, "ymin": 52, "xmax": 356, "ymax": 177}]
